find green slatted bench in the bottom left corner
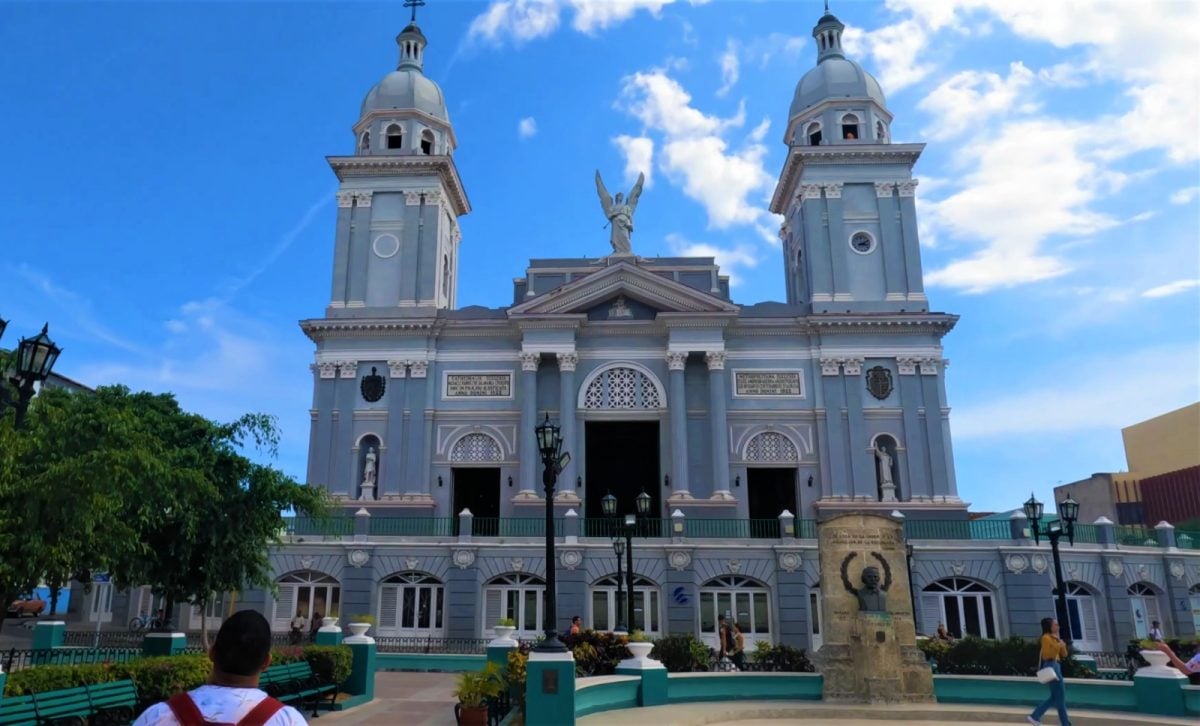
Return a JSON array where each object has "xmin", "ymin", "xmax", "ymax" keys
[{"xmin": 0, "ymin": 680, "xmax": 138, "ymax": 726}]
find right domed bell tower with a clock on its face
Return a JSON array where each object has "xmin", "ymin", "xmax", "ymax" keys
[{"xmin": 770, "ymin": 8, "xmax": 929, "ymax": 313}]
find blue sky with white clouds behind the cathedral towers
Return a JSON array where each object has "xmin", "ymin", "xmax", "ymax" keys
[{"xmin": 0, "ymin": 0, "xmax": 1200, "ymax": 510}]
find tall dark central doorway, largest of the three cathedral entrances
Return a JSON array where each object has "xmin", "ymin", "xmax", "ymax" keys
[{"xmin": 584, "ymin": 421, "xmax": 662, "ymax": 536}]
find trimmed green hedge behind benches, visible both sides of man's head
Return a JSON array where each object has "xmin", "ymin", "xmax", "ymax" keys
[{"xmin": 4, "ymin": 646, "xmax": 354, "ymax": 702}]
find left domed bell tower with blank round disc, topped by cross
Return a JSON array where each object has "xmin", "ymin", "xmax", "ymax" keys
[{"xmin": 328, "ymin": 2, "xmax": 470, "ymax": 317}]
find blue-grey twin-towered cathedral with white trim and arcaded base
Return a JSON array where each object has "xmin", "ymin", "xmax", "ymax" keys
[{"xmin": 241, "ymin": 7, "xmax": 1200, "ymax": 650}]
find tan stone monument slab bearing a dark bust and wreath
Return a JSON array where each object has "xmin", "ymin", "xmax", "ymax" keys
[{"xmin": 814, "ymin": 512, "xmax": 935, "ymax": 703}]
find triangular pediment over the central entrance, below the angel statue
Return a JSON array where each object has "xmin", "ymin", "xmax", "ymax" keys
[{"xmin": 509, "ymin": 262, "xmax": 738, "ymax": 319}]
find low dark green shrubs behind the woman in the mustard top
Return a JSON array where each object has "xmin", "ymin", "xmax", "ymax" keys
[{"xmin": 917, "ymin": 636, "xmax": 1096, "ymax": 678}]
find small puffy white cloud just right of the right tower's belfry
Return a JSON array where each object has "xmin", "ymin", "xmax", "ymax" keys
[{"xmin": 917, "ymin": 61, "xmax": 1036, "ymax": 139}]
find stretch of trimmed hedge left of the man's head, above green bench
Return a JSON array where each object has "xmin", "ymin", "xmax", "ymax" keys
[{"xmin": 5, "ymin": 655, "xmax": 212, "ymax": 701}]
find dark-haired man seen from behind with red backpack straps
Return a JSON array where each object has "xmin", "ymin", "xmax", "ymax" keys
[{"xmin": 133, "ymin": 610, "xmax": 307, "ymax": 726}]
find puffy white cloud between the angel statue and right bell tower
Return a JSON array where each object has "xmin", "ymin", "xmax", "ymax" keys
[{"xmin": 617, "ymin": 70, "xmax": 775, "ymax": 230}]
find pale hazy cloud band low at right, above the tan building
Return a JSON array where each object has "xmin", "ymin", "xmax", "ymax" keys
[{"xmin": 950, "ymin": 346, "xmax": 1200, "ymax": 440}]
